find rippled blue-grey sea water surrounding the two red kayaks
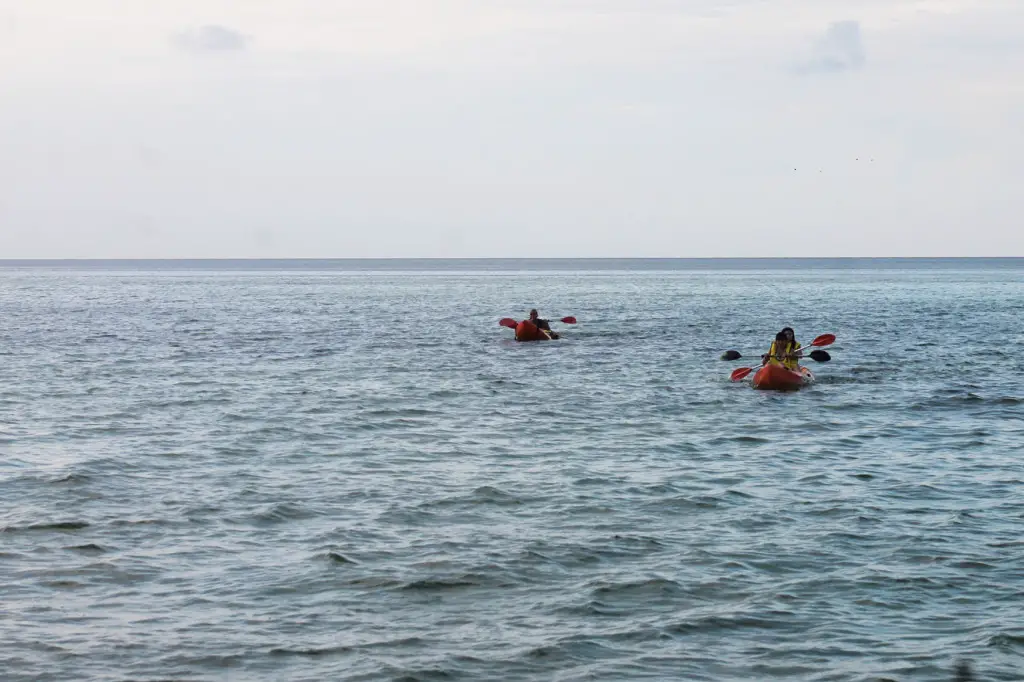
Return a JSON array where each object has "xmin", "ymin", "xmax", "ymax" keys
[{"xmin": 0, "ymin": 260, "xmax": 1024, "ymax": 682}]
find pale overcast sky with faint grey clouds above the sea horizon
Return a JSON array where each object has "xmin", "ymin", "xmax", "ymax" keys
[{"xmin": 0, "ymin": 0, "xmax": 1024, "ymax": 258}]
